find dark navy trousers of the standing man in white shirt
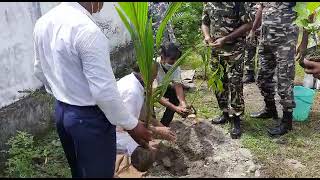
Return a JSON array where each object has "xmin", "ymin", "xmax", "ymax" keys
[{"xmin": 55, "ymin": 101, "xmax": 116, "ymax": 178}]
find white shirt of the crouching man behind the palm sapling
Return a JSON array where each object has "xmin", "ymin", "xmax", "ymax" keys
[{"xmin": 116, "ymin": 73, "xmax": 144, "ymax": 156}]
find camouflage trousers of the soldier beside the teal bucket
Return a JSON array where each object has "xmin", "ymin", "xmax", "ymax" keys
[{"xmin": 257, "ymin": 40, "xmax": 296, "ymax": 112}]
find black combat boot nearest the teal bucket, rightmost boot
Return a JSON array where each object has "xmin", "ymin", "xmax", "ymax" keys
[{"xmin": 268, "ymin": 111, "xmax": 292, "ymax": 136}]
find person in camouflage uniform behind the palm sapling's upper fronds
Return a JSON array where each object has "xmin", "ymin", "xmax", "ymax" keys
[{"xmin": 148, "ymin": 2, "xmax": 176, "ymax": 45}]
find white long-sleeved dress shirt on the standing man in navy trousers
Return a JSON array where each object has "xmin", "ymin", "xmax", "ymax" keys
[{"xmin": 34, "ymin": 2, "xmax": 138, "ymax": 130}]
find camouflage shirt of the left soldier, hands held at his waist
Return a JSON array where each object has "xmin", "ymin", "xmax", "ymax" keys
[{"xmin": 202, "ymin": 2, "xmax": 253, "ymax": 52}]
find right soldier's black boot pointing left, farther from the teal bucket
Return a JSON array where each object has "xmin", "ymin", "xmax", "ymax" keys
[{"xmin": 250, "ymin": 101, "xmax": 278, "ymax": 119}]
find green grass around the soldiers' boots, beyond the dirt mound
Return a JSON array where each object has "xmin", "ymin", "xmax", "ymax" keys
[{"xmin": 182, "ymin": 52, "xmax": 320, "ymax": 177}]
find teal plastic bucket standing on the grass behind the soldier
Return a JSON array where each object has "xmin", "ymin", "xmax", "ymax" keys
[{"xmin": 293, "ymin": 86, "xmax": 315, "ymax": 121}]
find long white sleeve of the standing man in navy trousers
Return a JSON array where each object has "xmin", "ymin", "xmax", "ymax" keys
[{"xmin": 76, "ymin": 26, "xmax": 138, "ymax": 130}]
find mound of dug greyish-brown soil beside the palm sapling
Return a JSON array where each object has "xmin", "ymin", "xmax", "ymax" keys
[{"xmin": 145, "ymin": 120, "xmax": 259, "ymax": 177}]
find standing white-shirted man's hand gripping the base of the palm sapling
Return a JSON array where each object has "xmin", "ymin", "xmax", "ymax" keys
[{"xmin": 128, "ymin": 121, "xmax": 152, "ymax": 147}]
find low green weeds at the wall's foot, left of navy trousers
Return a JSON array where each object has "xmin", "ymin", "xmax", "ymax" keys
[{"xmin": 5, "ymin": 131, "xmax": 70, "ymax": 178}]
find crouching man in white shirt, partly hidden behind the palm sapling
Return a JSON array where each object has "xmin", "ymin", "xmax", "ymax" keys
[{"xmin": 116, "ymin": 63, "xmax": 176, "ymax": 174}]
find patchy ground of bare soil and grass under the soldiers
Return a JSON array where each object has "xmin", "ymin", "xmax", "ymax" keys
[{"xmin": 147, "ymin": 63, "xmax": 320, "ymax": 177}]
